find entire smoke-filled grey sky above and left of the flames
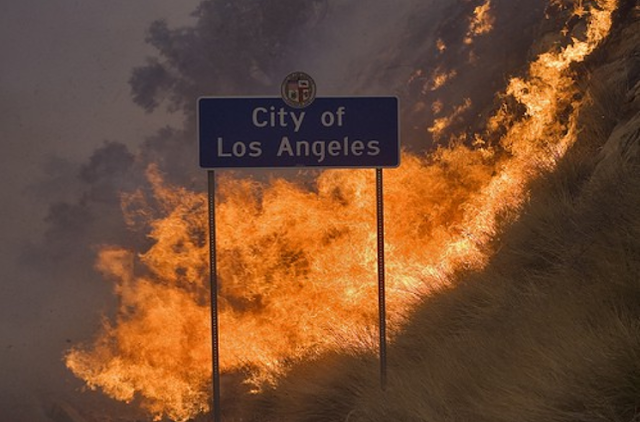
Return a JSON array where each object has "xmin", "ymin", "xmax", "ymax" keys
[{"xmin": 0, "ymin": 0, "xmax": 545, "ymax": 422}]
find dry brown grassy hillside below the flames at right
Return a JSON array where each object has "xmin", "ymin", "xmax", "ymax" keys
[{"xmin": 244, "ymin": 2, "xmax": 640, "ymax": 422}]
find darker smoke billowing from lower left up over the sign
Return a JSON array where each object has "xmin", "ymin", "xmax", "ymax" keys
[{"xmin": 0, "ymin": 0, "xmax": 549, "ymax": 422}]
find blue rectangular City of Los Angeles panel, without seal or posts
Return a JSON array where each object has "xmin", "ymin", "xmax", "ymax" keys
[{"xmin": 198, "ymin": 97, "xmax": 400, "ymax": 169}]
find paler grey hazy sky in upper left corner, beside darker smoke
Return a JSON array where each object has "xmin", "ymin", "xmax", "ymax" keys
[{"xmin": 0, "ymin": 0, "xmax": 198, "ymax": 242}]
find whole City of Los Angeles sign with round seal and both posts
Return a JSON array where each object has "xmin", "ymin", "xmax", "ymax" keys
[{"xmin": 198, "ymin": 88, "xmax": 400, "ymax": 422}]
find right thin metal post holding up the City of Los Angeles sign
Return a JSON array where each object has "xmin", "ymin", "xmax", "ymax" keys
[{"xmin": 376, "ymin": 167, "xmax": 387, "ymax": 390}]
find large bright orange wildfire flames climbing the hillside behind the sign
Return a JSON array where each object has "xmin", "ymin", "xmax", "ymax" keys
[{"xmin": 66, "ymin": 0, "xmax": 617, "ymax": 421}]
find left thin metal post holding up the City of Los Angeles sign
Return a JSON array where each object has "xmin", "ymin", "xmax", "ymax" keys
[{"xmin": 207, "ymin": 170, "xmax": 222, "ymax": 422}]
